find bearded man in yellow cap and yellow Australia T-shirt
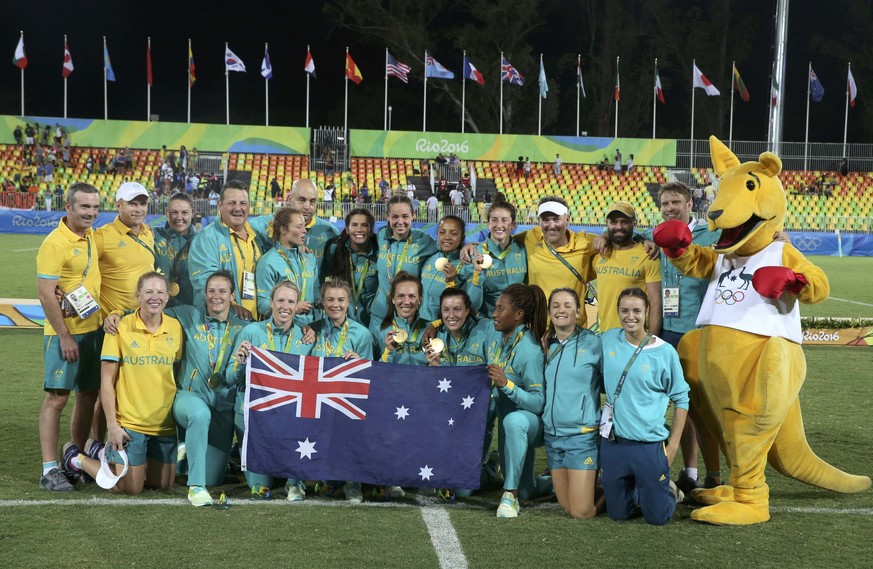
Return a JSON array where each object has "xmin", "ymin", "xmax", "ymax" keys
[{"xmin": 586, "ymin": 202, "xmax": 662, "ymax": 335}]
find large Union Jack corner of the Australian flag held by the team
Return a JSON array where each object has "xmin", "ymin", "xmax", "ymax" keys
[{"xmin": 247, "ymin": 348, "xmax": 373, "ymax": 420}]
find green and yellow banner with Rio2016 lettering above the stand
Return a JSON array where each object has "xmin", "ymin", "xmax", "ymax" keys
[{"xmin": 349, "ymin": 130, "xmax": 676, "ymax": 164}]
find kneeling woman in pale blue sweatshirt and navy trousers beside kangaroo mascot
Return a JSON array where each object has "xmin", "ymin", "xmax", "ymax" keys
[{"xmin": 600, "ymin": 288, "xmax": 688, "ymax": 525}]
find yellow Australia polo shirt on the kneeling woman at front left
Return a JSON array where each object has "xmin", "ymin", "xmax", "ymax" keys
[{"xmin": 100, "ymin": 310, "xmax": 183, "ymax": 436}]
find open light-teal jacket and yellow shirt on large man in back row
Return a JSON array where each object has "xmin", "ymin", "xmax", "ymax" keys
[{"xmin": 188, "ymin": 217, "xmax": 261, "ymax": 318}]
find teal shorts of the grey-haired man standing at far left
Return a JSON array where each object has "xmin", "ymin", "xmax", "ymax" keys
[{"xmin": 43, "ymin": 328, "xmax": 103, "ymax": 391}]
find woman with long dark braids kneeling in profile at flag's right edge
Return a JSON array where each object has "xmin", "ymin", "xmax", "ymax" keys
[{"xmin": 486, "ymin": 284, "xmax": 552, "ymax": 518}]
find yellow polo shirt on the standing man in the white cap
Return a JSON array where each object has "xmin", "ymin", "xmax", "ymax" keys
[{"xmin": 94, "ymin": 217, "xmax": 155, "ymax": 317}]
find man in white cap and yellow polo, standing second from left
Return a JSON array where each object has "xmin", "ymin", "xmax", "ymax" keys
[{"xmin": 95, "ymin": 182, "xmax": 155, "ymax": 318}]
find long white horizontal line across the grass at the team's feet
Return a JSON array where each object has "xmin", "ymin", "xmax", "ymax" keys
[{"xmin": 0, "ymin": 496, "xmax": 873, "ymax": 516}]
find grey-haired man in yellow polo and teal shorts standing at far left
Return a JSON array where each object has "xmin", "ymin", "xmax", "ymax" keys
[{"xmin": 36, "ymin": 182, "xmax": 102, "ymax": 492}]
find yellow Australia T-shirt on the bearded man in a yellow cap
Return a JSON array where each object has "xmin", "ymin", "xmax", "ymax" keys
[{"xmin": 591, "ymin": 243, "xmax": 661, "ymax": 333}]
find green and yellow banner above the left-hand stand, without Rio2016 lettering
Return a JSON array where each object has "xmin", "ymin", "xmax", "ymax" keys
[{"xmin": 0, "ymin": 116, "xmax": 309, "ymax": 154}]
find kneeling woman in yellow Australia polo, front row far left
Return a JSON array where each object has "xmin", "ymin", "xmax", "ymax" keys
[{"xmin": 64, "ymin": 272, "xmax": 183, "ymax": 495}]
